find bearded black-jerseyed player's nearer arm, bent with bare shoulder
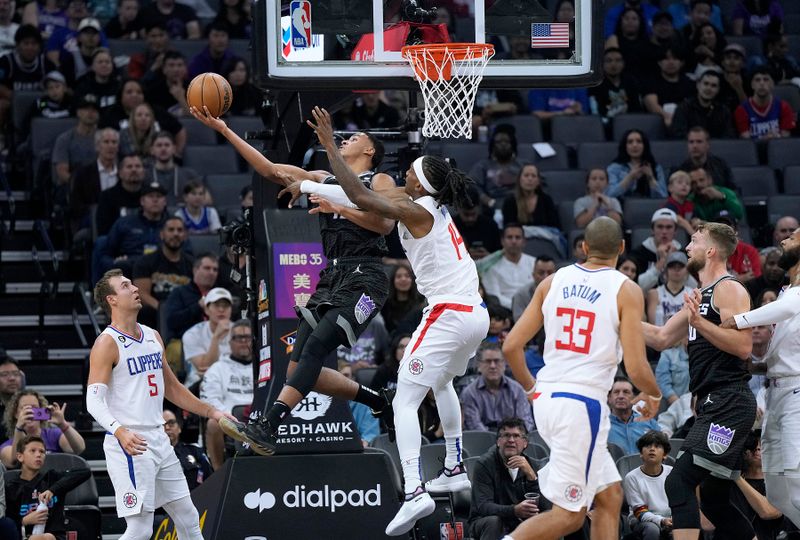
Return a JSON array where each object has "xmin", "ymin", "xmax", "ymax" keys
[{"xmin": 684, "ymin": 279, "xmax": 753, "ymax": 360}]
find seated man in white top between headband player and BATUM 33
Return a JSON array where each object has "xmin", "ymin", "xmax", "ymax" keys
[{"xmin": 478, "ymin": 223, "xmax": 536, "ymax": 309}]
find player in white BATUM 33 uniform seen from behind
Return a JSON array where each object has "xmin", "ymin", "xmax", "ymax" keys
[{"xmin": 503, "ymin": 217, "xmax": 661, "ymax": 540}]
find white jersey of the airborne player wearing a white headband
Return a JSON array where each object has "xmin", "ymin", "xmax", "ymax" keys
[{"xmin": 397, "ymin": 195, "xmax": 483, "ymax": 305}]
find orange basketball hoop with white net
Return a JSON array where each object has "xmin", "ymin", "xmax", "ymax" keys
[{"xmin": 401, "ymin": 43, "xmax": 494, "ymax": 139}]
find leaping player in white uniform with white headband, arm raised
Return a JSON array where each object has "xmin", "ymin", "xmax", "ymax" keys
[{"xmin": 300, "ymin": 107, "xmax": 489, "ymax": 536}]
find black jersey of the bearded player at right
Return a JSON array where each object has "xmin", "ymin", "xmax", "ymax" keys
[{"xmin": 689, "ymin": 276, "xmax": 750, "ymax": 395}]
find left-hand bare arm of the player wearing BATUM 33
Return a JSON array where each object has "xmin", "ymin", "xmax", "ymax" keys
[{"xmin": 503, "ymin": 276, "xmax": 553, "ymax": 399}]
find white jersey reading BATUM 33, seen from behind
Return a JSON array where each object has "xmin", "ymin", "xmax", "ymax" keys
[{"xmin": 537, "ymin": 264, "xmax": 628, "ymax": 392}]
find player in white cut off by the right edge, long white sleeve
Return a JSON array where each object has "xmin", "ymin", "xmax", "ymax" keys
[{"xmin": 722, "ymin": 229, "xmax": 800, "ymax": 526}]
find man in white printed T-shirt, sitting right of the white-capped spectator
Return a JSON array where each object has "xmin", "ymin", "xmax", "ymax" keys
[{"xmin": 200, "ymin": 320, "xmax": 253, "ymax": 470}]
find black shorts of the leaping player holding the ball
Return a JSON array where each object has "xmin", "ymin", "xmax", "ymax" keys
[{"xmin": 295, "ymin": 257, "xmax": 389, "ymax": 347}]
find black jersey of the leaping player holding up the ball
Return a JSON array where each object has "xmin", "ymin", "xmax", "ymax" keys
[{"xmin": 319, "ymin": 171, "xmax": 387, "ymax": 261}]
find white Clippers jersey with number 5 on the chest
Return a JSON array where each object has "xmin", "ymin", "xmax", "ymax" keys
[{"xmin": 103, "ymin": 324, "xmax": 164, "ymax": 427}]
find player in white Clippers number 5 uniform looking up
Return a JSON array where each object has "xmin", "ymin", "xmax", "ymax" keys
[{"xmin": 86, "ymin": 269, "xmax": 234, "ymax": 540}]
